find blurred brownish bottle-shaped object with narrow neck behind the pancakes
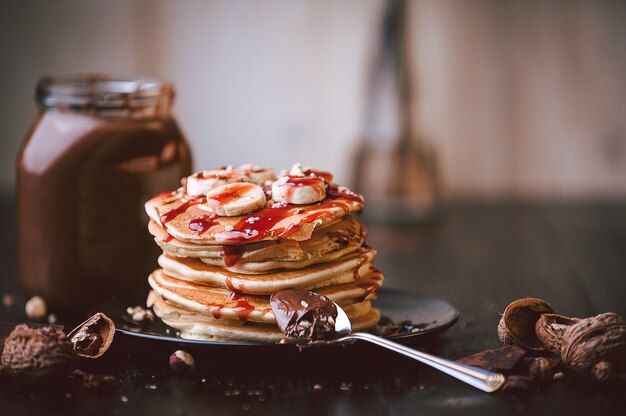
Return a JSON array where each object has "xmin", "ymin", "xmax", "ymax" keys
[{"xmin": 352, "ymin": 0, "xmax": 439, "ymax": 222}]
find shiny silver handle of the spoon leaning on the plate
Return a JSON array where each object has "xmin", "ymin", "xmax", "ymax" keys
[{"xmin": 340, "ymin": 332, "xmax": 505, "ymax": 393}]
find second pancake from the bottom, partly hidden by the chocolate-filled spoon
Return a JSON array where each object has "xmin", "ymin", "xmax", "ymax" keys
[{"xmin": 148, "ymin": 269, "xmax": 384, "ymax": 323}]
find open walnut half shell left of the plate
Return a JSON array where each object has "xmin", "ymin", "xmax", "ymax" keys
[{"xmin": 68, "ymin": 312, "xmax": 115, "ymax": 358}]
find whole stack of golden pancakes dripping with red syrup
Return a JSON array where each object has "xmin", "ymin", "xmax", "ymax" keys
[{"xmin": 145, "ymin": 164, "xmax": 383, "ymax": 342}]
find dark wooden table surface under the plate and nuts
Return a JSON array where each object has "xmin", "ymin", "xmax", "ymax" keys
[{"xmin": 0, "ymin": 198, "xmax": 626, "ymax": 415}]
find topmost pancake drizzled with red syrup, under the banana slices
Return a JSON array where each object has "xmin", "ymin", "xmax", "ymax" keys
[{"xmin": 145, "ymin": 190, "xmax": 363, "ymax": 245}]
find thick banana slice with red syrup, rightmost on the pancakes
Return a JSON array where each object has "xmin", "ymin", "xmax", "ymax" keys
[{"xmin": 272, "ymin": 175, "xmax": 326, "ymax": 205}]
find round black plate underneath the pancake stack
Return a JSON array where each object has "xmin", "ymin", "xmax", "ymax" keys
[{"xmin": 100, "ymin": 288, "xmax": 459, "ymax": 348}]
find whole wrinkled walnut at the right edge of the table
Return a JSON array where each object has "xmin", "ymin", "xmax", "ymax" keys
[{"xmin": 561, "ymin": 312, "xmax": 626, "ymax": 381}]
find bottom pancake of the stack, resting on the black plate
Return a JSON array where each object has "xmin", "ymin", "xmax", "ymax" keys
[{"xmin": 152, "ymin": 296, "xmax": 380, "ymax": 343}]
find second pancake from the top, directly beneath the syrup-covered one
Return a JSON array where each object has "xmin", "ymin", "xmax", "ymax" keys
[{"xmin": 148, "ymin": 215, "xmax": 365, "ymax": 274}]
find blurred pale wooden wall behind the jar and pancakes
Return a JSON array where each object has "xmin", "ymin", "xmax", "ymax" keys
[{"xmin": 0, "ymin": 0, "xmax": 626, "ymax": 198}]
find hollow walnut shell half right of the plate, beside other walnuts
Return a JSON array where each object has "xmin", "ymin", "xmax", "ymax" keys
[{"xmin": 498, "ymin": 298, "xmax": 554, "ymax": 350}]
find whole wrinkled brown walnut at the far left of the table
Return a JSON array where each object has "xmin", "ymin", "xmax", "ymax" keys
[{"xmin": 2, "ymin": 324, "xmax": 73, "ymax": 381}]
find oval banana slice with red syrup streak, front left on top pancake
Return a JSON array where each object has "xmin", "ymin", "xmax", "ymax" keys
[{"xmin": 206, "ymin": 182, "xmax": 265, "ymax": 217}]
